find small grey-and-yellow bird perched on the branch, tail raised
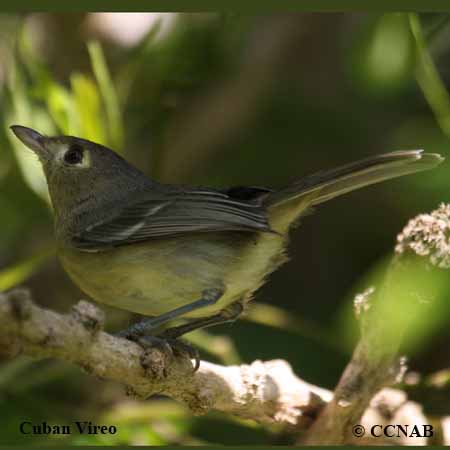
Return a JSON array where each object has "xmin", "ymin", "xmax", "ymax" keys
[{"xmin": 11, "ymin": 125, "xmax": 443, "ymax": 362}]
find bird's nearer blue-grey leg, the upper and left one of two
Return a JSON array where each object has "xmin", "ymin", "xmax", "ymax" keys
[{"xmin": 116, "ymin": 288, "xmax": 223, "ymax": 340}]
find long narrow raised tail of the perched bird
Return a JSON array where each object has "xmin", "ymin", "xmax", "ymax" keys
[{"xmin": 264, "ymin": 150, "xmax": 444, "ymax": 232}]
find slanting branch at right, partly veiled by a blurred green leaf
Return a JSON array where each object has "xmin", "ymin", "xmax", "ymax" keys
[{"xmin": 305, "ymin": 204, "xmax": 450, "ymax": 445}]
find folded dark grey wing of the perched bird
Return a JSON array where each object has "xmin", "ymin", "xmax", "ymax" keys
[{"xmin": 72, "ymin": 189, "xmax": 271, "ymax": 251}]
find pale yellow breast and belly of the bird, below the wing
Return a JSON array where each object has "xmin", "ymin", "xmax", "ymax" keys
[{"xmin": 59, "ymin": 232, "xmax": 284, "ymax": 318}]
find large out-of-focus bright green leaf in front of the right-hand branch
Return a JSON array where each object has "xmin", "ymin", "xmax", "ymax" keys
[{"xmin": 338, "ymin": 255, "xmax": 450, "ymax": 354}]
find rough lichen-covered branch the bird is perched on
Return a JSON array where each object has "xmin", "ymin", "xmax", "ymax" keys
[{"xmin": 0, "ymin": 290, "xmax": 332, "ymax": 425}]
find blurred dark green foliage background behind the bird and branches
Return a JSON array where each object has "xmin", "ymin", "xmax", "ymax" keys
[{"xmin": 0, "ymin": 13, "xmax": 450, "ymax": 444}]
